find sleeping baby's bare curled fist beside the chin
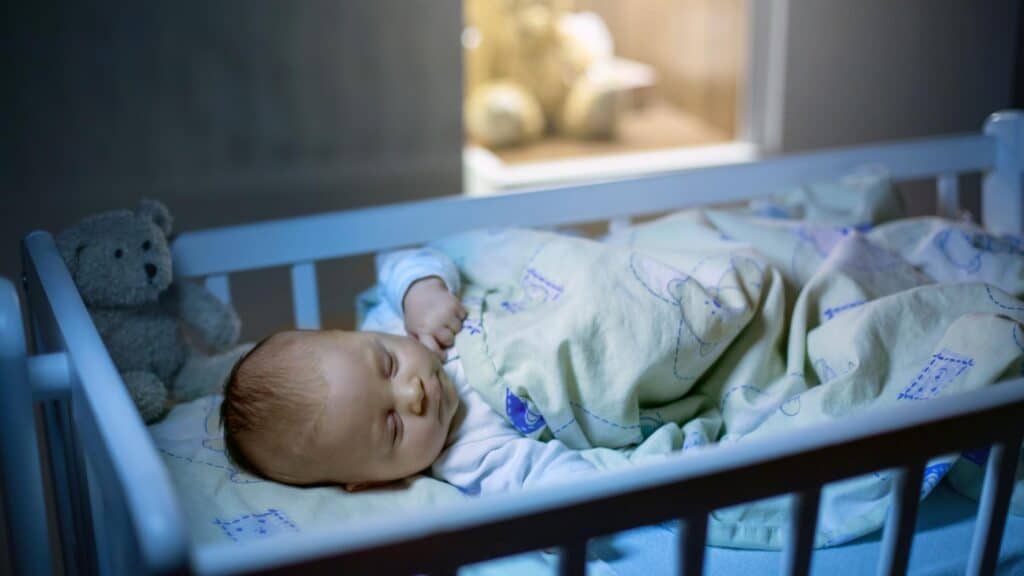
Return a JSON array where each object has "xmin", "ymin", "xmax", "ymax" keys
[{"xmin": 401, "ymin": 276, "xmax": 466, "ymax": 360}]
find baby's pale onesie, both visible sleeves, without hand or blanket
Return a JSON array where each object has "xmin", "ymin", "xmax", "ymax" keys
[{"xmin": 359, "ymin": 243, "xmax": 595, "ymax": 495}]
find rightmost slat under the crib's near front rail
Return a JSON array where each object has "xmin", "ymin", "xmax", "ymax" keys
[{"xmin": 967, "ymin": 433, "xmax": 1021, "ymax": 575}]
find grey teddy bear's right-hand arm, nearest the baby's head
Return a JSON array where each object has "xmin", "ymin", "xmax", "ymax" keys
[{"xmin": 164, "ymin": 282, "xmax": 241, "ymax": 353}]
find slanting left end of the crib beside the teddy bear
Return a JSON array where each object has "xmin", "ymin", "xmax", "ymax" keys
[{"xmin": 24, "ymin": 233, "xmax": 188, "ymax": 574}]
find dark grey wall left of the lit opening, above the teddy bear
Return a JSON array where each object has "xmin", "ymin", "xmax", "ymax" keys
[{"xmin": 0, "ymin": 0, "xmax": 462, "ymax": 337}]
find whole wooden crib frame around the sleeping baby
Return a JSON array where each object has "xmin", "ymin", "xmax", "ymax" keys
[{"xmin": 6, "ymin": 112, "xmax": 1024, "ymax": 575}]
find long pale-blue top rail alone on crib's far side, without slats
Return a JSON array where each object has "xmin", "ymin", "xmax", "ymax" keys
[{"xmin": 173, "ymin": 135, "xmax": 996, "ymax": 278}]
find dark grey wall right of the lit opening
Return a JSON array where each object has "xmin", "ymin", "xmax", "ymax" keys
[{"xmin": 781, "ymin": 0, "xmax": 1020, "ymax": 213}]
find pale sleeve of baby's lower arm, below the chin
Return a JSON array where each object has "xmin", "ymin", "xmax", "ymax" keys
[{"xmin": 431, "ymin": 373, "xmax": 596, "ymax": 495}]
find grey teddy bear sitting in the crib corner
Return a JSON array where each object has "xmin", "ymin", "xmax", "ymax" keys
[{"xmin": 57, "ymin": 200, "xmax": 240, "ymax": 423}]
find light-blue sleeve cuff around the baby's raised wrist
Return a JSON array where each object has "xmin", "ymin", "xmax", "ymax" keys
[{"xmin": 376, "ymin": 248, "xmax": 461, "ymax": 317}]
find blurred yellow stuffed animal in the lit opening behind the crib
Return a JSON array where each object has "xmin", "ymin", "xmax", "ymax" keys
[{"xmin": 463, "ymin": 0, "xmax": 621, "ymax": 148}]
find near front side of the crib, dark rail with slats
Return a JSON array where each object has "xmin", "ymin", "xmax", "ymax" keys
[{"xmin": 196, "ymin": 378, "xmax": 1024, "ymax": 576}]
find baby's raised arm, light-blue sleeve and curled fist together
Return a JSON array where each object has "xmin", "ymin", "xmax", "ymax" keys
[{"xmin": 377, "ymin": 248, "xmax": 466, "ymax": 357}]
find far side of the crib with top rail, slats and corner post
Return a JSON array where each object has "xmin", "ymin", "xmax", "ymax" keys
[{"xmin": 172, "ymin": 112, "xmax": 1024, "ymax": 328}]
